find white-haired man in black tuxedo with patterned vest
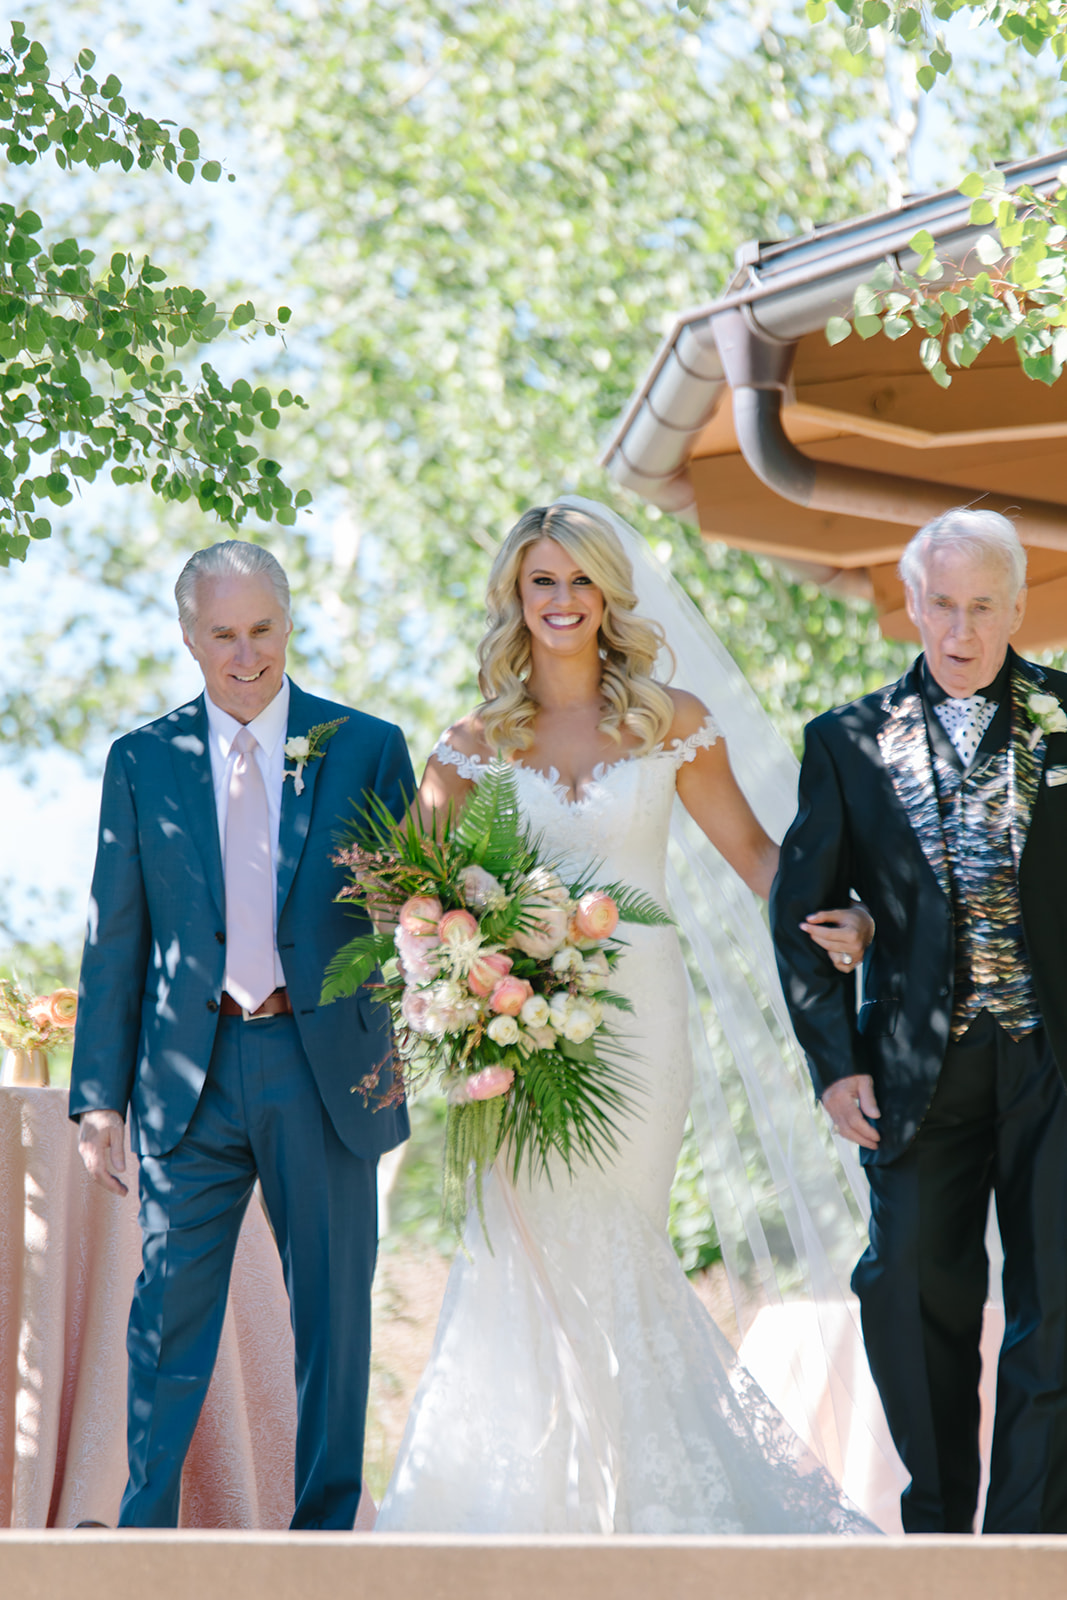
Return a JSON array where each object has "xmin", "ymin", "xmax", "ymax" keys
[{"xmin": 771, "ymin": 510, "xmax": 1067, "ymax": 1533}]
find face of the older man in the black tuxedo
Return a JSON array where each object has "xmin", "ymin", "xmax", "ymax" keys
[{"xmin": 907, "ymin": 549, "xmax": 1025, "ymax": 699}]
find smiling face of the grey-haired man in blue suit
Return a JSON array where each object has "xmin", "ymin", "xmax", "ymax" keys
[{"xmin": 182, "ymin": 576, "xmax": 293, "ymax": 723}]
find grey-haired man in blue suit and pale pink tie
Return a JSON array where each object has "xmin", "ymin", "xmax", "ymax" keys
[{"xmin": 70, "ymin": 539, "xmax": 414, "ymax": 1528}]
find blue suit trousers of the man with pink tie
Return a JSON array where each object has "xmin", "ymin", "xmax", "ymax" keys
[{"xmin": 118, "ymin": 1016, "xmax": 378, "ymax": 1528}]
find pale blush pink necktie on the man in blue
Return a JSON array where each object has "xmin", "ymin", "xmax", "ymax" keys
[{"xmin": 226, "ymin": 728, "xmax": 274, "ymax": 1011}]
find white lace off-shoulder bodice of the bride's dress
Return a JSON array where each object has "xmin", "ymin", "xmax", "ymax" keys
[{"xmin": 434, "ymin": 714, "xmax": 721, "ymax": 901}]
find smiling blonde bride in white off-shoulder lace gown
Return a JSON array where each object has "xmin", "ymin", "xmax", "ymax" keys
[{"xmin": 378, "ymin": 502, "xmax": 877, "ymax": 1534}]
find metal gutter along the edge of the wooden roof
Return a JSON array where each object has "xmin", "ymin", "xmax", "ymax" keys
[{"xmin": 600, "ymin": 150, "xmax": 1067, "ymax": 520}]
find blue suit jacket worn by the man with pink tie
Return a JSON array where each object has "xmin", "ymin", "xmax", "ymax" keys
[{"xmin": 70, "ymin": 683, "xmax": 414, "ymax": 1157}]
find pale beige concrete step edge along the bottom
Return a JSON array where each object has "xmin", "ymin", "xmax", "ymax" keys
[{"xmin": 0, "ymin": 1530, "xmax": 1067, "ymax": 1600}]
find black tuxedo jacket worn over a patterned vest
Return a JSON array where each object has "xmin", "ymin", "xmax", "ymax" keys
[{"xmin": 771, "ymin": 653, "xmax": 1067, "ymax": 1163}]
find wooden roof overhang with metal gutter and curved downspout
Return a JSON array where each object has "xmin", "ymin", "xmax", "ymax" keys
[{"xmin": 603, "ymin": 150, "xmax": 1067, "ymax": 650}]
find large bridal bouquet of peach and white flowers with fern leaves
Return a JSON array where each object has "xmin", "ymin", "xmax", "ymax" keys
[{"xmin": 322, "ymin": 760, "xmax": 670, "ymax": 1230}]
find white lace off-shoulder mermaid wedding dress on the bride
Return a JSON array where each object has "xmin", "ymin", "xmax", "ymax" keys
[{"xmin": 378, "ymin": 717, "xmax": 877, "ymax": 1534}]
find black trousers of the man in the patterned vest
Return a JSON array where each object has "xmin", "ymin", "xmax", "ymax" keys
[{"xmin": 853, "ymin": 1011, "xmax": 1067, "ymax": 1533}]
